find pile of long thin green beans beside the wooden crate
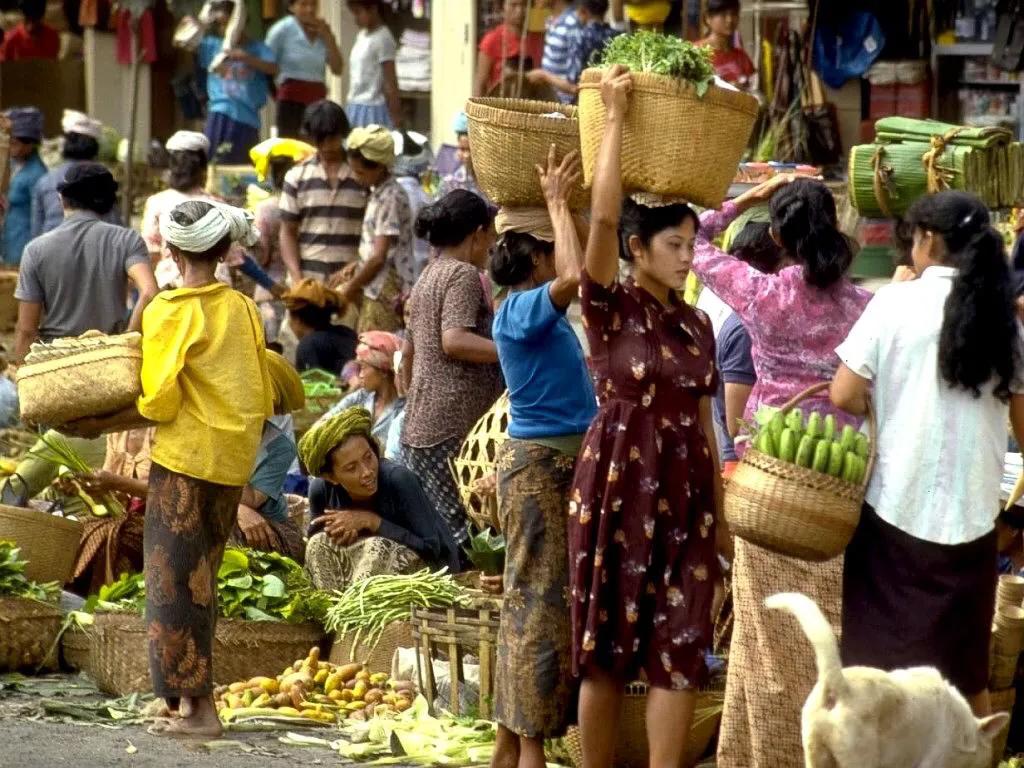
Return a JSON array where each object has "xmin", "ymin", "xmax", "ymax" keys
[{"xmin": 324, "ymin": 568, "xmax": 466, "ymax": 647}]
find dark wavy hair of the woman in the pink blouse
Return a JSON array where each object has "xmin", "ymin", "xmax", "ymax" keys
[{"xmin": 768, "ymin": 178, "xmax": 853, "ymax": 290}]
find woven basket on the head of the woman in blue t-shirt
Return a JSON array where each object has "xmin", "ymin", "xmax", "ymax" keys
[{"xmin": 466, "ymin": 98, "xmax": 590, "ymax": 210}]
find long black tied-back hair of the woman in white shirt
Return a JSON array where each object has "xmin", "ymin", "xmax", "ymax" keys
[{"xmin": 906, "ymin": 191, "xmax": 1020, "ymax": 402}]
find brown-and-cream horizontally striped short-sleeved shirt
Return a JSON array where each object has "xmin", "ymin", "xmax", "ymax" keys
[{"xmin": 280, "ymin": 155, "xmax": 368, "ymax": 278}]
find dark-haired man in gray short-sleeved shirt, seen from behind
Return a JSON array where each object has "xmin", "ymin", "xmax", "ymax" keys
[{"xmin": 14, "ymin": 163, "xmax": 157, "ymax": 364}]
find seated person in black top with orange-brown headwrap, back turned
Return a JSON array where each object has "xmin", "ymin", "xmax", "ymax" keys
[{"xmin": 284, "ymin": 279, "xmax": 356, "ymax": 374}]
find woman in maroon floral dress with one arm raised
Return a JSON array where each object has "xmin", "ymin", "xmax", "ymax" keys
[{"xmin": 569, "ymin": 68, "xmax": 721, "ymax": 768}]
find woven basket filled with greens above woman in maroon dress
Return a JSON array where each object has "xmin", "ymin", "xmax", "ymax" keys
[{"xmin": 581, "ymin": 70, "xmax": 759, "ymax": 208}]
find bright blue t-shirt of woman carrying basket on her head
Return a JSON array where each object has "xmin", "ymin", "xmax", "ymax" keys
[{"xmin": 493, "ymin": 284, "xmax": 597, "ymax": 439}]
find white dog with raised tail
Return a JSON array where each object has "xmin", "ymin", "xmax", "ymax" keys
[{"xmin": 765, "ymin": 593, "xmax": 1010, "ymax": 768}]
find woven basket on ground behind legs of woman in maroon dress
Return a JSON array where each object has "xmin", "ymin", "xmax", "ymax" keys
[{"xmin": 565, "ymin": 683, "xmax": 725, "ymax": 768}]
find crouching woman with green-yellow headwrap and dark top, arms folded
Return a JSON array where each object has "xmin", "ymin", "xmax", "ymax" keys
[{"xmin": 299, "ymin": 408, "xmax": 460, "ymax": 590}]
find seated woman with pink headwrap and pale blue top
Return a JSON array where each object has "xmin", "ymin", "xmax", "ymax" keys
[{"xmin": 321, "ymin": 331, "xmax": 406, "ymax": 445}]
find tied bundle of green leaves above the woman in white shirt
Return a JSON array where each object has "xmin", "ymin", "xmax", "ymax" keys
[{"xmin": 849, "ymin": 117, "xmax": 1024, "ymax": 218}]
